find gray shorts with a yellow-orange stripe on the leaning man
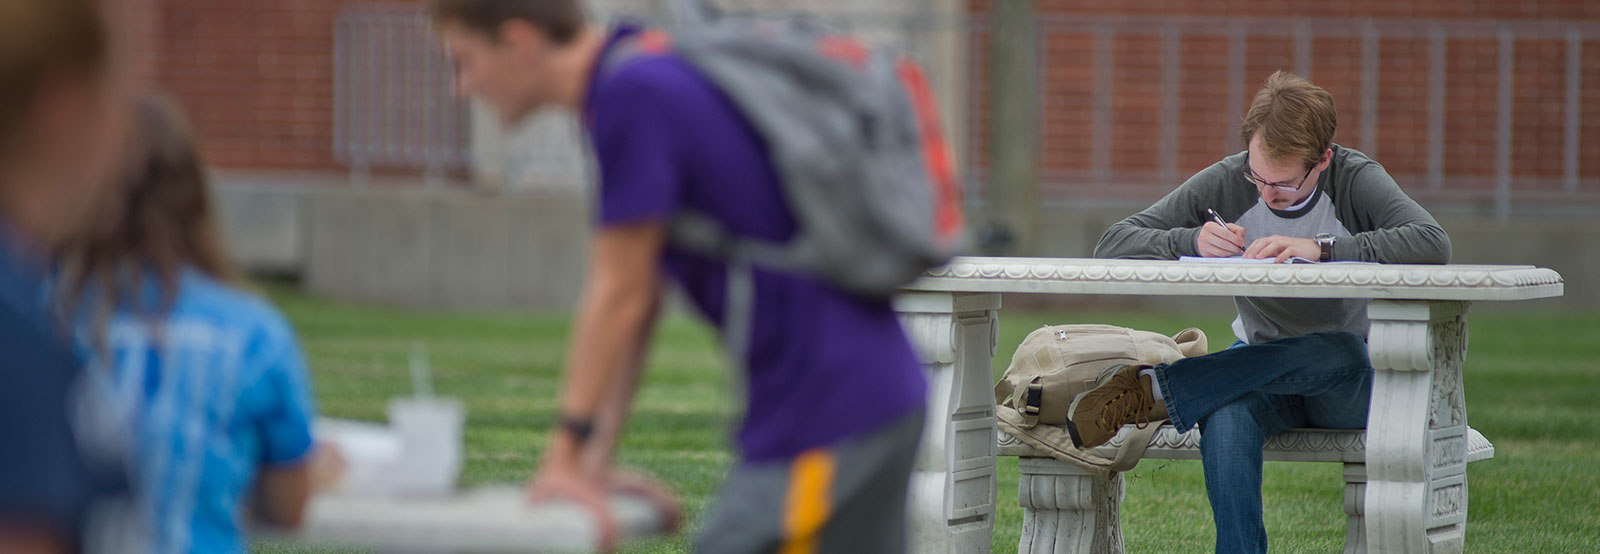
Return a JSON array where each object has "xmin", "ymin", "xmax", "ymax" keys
[{"xmin": 694, "ymin": 408, "xmax": 923, "ymax": 554}]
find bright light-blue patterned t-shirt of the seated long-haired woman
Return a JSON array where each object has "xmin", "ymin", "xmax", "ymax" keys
[{"xmin": 80, "ymin": 269, "xmax": 314, "ymax": 552}]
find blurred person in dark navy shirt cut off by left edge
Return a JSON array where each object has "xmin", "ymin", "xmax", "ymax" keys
[{"xmin": 0, "ymin": 0, "xmax": 138, "ymax": 554}]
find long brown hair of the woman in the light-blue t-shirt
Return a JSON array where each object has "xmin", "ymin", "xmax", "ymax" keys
[{"xmin": 58, "ymin": 96, "xmax": 238, "ymax": 341}]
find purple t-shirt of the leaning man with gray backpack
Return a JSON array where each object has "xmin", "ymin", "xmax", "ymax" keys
[{"xmin": 584, "ymin": 26, "xmax": 926, "ymax": 461}]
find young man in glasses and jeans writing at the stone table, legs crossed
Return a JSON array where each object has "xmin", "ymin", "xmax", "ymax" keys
[{"xmin": 1088, "ymin": 72, "xmax": 1450, "ymax": 552}]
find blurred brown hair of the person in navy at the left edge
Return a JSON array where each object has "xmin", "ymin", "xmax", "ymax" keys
[{"xmin": 0, "ymin": 0, "xmax": 110, "ymax": 155}]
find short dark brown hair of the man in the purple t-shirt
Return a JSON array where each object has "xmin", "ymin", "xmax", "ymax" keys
[{"xmin": 429, "ymin": 0, "xmax": 584, "ymax": 45}]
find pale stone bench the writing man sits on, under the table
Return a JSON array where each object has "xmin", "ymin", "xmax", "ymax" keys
[{"xmin": 997, "ymin": 424, "xmax": 1494, "ymax": 554}]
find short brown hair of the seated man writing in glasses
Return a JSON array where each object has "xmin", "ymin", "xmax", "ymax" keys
[{"xmin": 1238, "ymin": 70, "xmax": 1339, "ymax": 170}]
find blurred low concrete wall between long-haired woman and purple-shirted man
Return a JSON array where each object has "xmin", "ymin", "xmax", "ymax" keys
[{"xmin": 218, "ymin": 183, "xmax": 589, "ymax": 312}]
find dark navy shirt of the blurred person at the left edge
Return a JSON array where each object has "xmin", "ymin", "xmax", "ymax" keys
[{"xmin": 0, "ymin": 221, "xmax": 128, "ymax": 543}]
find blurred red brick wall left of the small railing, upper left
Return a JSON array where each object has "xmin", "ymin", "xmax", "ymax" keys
[{"xmin": 136, "ymin": 0, "xmax": 416, "ymax": 170}]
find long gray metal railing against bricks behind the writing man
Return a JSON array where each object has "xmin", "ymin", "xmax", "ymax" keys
[{"xmin": 1011, "ymin": 14, "xmax": 1600, "ymax": 218}]
